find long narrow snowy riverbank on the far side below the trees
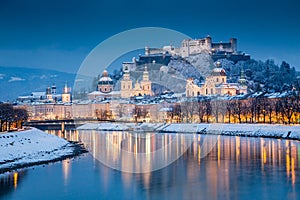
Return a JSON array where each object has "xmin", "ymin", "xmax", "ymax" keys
[{"xmin": 77, "ymin": 123, "xmax": 300, "ymax": 140}]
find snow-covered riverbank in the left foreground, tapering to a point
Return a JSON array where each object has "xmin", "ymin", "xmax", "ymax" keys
[{"xmin": 0, "ymin": 128, "xmax": 86, "ymax": 173}]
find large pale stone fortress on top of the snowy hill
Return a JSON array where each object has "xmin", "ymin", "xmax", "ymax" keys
[{"xmin": 123, "ymin": 36, "xmax": 250, "ymax": 71}]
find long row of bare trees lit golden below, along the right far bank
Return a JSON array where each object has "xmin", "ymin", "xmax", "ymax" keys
[{"xmin": 167, "ymin": 95, "xmax": 300, "ymax": 124}]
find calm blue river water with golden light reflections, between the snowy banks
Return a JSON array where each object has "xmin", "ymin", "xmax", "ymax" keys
[{"xmin": 0, "ymin": 131, "xmax": 300, "ymax": 199}]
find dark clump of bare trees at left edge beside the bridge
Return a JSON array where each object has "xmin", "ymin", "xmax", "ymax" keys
[{"xmin": 0, "ymin": 103, "xmax": 28, "ymax": 132}]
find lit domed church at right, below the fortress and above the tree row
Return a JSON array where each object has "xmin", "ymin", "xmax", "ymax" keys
[{"xmin": 186, "ymin": 63, "xmax": 247, "ymax": 97}]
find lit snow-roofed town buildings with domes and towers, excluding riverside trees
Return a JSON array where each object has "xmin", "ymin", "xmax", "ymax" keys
[{"xmin": 18, "ymin": 56, "xmax": 247, "ymax": 121}]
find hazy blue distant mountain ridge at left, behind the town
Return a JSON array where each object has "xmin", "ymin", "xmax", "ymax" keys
[{"xmin": 0, "ymin": 66, "xmax": 76, "ymax": 101}]
